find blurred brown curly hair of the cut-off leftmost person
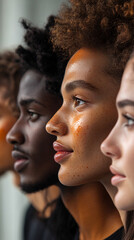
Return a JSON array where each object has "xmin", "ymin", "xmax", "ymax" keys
[{"xmin": 0, "ymin": 51, "xmax": 23, "ymax": 116}]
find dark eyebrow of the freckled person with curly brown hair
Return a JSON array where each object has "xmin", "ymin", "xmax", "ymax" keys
[{"xmin": 65, "ymin": 80, "xmax": 97, "ymax": 92}]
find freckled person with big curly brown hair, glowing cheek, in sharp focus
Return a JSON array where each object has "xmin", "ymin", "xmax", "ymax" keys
[{"xmin": 46, "ymin": 0, "xmax": 134, "ymax": 240}]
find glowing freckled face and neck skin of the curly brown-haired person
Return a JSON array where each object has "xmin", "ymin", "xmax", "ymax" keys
[{"xmin": 46, "ymin": 49, "xmax": 122, "ymax": 240}]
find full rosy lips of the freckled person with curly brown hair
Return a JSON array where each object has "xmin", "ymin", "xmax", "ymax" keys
[{"xmin": 53, "ymin": 141, "xmax": 73, "ymax": 163}]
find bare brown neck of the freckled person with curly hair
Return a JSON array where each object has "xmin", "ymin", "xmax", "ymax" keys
[{"xmin": 62, "ymin": 183, "xmax": 122, "ymax": 240}]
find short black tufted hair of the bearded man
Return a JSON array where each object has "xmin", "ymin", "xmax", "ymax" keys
[{"xmin": 16, "ymin": 16, "xmax": 67, "ymax": 94}]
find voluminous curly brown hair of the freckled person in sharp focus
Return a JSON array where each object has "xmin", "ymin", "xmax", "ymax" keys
[{"xmin": 51, "ymin": 0, "xmax": 134, "ymax": 78}]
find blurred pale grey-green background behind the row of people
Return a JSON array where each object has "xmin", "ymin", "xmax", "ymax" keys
[{"xmin": 0, "ymin": 0, "xmax": 67, "ymax": 240}]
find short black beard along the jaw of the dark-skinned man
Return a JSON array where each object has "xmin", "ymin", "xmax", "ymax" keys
[{"xmin": 20, "ymin": 175, "xmax": 58, "ymax": 193}]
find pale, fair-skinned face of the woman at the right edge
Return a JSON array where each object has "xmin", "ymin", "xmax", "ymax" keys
[{"xmin": 101, "ymin": 57, "xmax": 134, "ymax": 216}]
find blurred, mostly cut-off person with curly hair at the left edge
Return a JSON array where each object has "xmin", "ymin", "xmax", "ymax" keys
[{"xmin": 0, "ymin": 51, "xmax": 22, "ymax": 176}]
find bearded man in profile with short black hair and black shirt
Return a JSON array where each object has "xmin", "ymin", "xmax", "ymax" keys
[{"xmin": 7, "ymin": 16, "xmax": 77, "ymax": 240}]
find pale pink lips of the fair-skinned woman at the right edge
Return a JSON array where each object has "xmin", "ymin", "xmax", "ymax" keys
[{"xmin": 110, "ymin": 166, "xmax": 126, "ymax": 186}]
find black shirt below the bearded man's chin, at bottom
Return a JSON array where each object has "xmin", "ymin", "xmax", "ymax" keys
[{"xmin": 23, "ymin": 202, "xmax": 78, "ymax": 240}]
